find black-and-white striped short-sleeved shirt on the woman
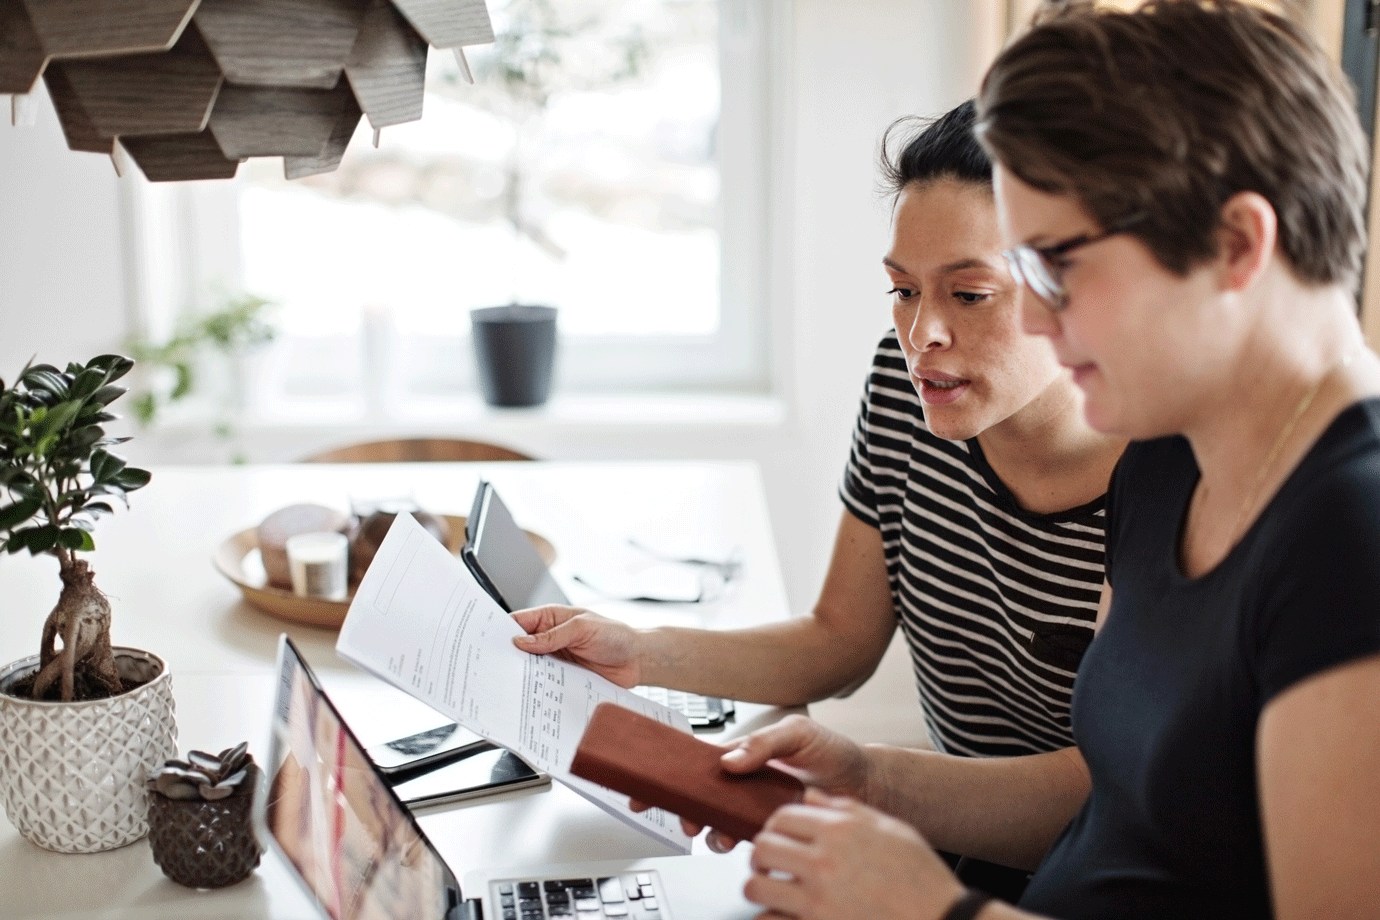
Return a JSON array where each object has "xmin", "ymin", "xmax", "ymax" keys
[{"xmin": 840, "ymin": 331, "xmax": 1105, "ymax": 756}]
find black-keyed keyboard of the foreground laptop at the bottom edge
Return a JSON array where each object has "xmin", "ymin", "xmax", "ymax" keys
[{"xmin": 493, "ymin": 872, "xmax": 662, "ymax": 920}]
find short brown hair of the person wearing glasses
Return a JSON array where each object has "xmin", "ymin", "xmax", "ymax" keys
[{"xmin": 977, "ymin": 0, "xmax": 1369, "ymax": 286}]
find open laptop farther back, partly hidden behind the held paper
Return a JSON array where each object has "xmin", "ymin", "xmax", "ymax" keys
[{"xmin": 460, "ymin": 480, "xmax": 736, "ymax": 732}]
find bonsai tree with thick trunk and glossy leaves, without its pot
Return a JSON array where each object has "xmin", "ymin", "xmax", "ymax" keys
[{"xmin": 0, "ymin": 354, "xmax": 149, "ymax": 702}]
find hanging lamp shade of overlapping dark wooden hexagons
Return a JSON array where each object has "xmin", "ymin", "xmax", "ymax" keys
[{"xmin": 0, "ymin": 0, "xmax": 494, "ymax": 182}]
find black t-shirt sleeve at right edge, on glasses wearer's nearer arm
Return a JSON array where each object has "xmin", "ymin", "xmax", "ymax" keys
[{"xmin": 1250, "ymin": 455, "xmax": 1380, "ymax": 705}]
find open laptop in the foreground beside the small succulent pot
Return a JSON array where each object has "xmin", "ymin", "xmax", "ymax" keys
[{"xmin": 254, "ymin": 634, "xmax": 758, "ymax": 920}]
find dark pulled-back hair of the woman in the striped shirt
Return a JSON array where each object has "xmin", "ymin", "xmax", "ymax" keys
[{"xmin": 878, "ymin": 99, "xmax": 992, "ymax": 199}]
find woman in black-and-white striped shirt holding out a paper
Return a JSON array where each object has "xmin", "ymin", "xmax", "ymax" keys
[{"xmin": 516, "ymin": 102, "xmax": 1123, "ymax": 811}]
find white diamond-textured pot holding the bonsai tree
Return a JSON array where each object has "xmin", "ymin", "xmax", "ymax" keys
[{"xmin": 0, "ymin": 648, "xmax": 177, "ymax": 852}]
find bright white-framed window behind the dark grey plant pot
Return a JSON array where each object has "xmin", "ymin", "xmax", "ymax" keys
[{"xmin": 145, "ymin": 0, "xmax": 773, "ymax": 417}]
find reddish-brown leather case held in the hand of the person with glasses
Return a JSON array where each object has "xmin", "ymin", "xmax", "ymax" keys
[{"xmin": 570, "ymin": 702, "xmax": 805, "ymax": 840}]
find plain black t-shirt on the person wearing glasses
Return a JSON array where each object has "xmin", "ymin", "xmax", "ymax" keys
[{"xmin": 1021, "ymin": 400, "xmax": 1380, "ymax": 920}]
